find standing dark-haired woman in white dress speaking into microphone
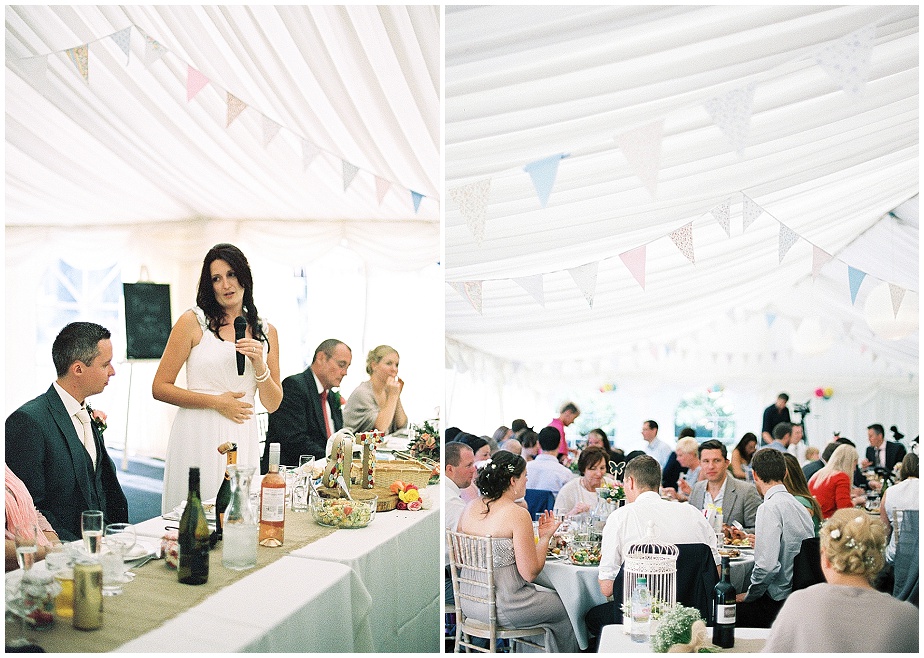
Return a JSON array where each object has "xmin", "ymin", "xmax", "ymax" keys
[{"xmin": 151, "ymin": 244, "xmax": 282, "ymax": 512}]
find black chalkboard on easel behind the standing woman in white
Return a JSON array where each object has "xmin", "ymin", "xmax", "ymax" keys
[{"xmin": 122, "ymin": 283, "xmax": 171, "ymax": 359}]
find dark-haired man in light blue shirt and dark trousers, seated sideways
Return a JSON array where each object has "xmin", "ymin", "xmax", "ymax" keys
[{"xmin": 735, "ymin": 448, "xmax": 815, "ymax": 628}]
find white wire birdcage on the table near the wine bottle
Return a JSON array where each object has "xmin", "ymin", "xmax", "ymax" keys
[{"xmin": 622, "ymin": 521, "xmax": 679, "ymax": 633}]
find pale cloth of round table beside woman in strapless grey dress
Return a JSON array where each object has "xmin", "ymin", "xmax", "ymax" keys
[{"xmin": 534, "ymin": 551, "xmax": 754, "ymax": 649}]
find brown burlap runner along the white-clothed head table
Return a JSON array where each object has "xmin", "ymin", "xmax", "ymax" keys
[{"xmin": 19, "ymin": 512, "xmax": 338, "ymax": 653}]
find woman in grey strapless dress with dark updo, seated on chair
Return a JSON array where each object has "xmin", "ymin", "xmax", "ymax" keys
[{"xmin": 458, "ymin": 448, "xmax": 578, "ymax": 652}]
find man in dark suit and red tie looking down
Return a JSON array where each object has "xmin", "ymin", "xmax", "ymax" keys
[{"xmin": 260, "ymin": 338, "xmax": 353, "ymax": 473}]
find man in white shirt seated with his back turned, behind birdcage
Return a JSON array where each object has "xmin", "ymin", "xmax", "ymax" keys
[{"xmin": 585, "ymin": 455, "xmax": 721, "ymax": 637}]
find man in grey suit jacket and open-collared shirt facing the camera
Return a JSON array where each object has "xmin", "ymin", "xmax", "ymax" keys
[{"xmin": 690, "ymin": 439, "xmax": 763, "ymax": 533}]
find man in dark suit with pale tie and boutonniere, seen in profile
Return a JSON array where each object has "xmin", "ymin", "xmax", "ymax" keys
[{"xmin": 6, "ymin": 322, "xmax": 128, "ymax": 541}]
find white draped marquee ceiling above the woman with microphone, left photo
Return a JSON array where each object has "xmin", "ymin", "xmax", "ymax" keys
[{"xmin": 5, "ymin": 5, "xmax": 441, "ymax": 226}]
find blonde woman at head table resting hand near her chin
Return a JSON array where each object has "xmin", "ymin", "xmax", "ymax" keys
[{"xmin": 343, "ymin": 345, "xmax": 407, "ymax": 434}]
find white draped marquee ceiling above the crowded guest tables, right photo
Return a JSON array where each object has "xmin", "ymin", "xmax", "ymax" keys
[{"xmin": 444, "ymin": 6, "xmax": 919, "ymax": 394}]
